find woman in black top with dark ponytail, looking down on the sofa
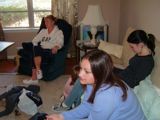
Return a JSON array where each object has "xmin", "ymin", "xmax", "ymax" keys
[{"xmin": 115, "ymin": 30, "xmax": 155, "ymax": 88}]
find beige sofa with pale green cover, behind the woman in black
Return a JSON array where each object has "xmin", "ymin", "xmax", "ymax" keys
[{"xmin": 98, "ymin": 28, "xmax": 160, "ymax": 120}]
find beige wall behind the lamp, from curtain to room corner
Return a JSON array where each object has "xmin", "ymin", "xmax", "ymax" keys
[{"xmin": 78, "ymin": 0, "xmax": 120, "ymax": 43}]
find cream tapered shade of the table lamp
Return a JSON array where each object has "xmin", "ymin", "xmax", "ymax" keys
[{"xmin": 81, "ymin": 5, "xmax": 106, "ymax": 26}]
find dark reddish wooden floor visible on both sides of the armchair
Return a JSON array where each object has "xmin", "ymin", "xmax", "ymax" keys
[{"xmin": 0, "ymin": 58, "xmax": 76, "ymax": 74}]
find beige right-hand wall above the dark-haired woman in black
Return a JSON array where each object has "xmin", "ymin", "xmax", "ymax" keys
[{"xmin": 119, "ymin": 0, "xmax": 160, "ymax": 40}]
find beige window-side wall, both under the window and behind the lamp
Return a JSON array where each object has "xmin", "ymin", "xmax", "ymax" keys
[{"xmin": 5, "ymin": 0, "xmax": 120, "ymax": 57}]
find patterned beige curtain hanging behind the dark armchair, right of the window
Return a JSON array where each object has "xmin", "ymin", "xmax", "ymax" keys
[{"xmin": 52, "ymin": 0, "xmax": 78, "ymax": 56}]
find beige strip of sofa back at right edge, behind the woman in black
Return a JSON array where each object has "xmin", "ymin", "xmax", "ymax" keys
[{"xmin": 151, "ymin": 41, "xmax": 160, "ymax": 88}]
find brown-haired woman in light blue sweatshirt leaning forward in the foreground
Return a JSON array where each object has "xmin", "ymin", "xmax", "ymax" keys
[{"xmin": 47, "ymin": 50, "xmax": 146, "ymax": 120}]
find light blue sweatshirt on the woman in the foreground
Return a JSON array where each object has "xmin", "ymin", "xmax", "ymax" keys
[{"xmin": 62, "ymin": 85, "xmax": 146, "ymax": 120}]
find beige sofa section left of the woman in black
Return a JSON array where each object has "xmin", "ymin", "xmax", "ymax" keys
[{"xmin": 98, "ymin": 27, "xmax": 135, "ymax": 69}]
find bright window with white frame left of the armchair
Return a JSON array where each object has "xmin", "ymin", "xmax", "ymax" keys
[{"xmin": 0, "ymin": 0, "xmax": 51, "ymax": 28}]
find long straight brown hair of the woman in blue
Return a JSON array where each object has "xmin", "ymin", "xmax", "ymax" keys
[{"xmin": 82, "ymin": 50, "xmax": 127, "ymax": 103}]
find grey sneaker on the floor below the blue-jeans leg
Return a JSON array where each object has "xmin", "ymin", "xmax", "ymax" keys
[{"xmin": 52, "ymin": 104, "xmax": 71, "ymax": 112}]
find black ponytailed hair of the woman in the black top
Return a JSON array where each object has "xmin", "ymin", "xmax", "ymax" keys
[{"xmin": 127, "ymin": 30, "xmax": 155, "ymax": 55}]
